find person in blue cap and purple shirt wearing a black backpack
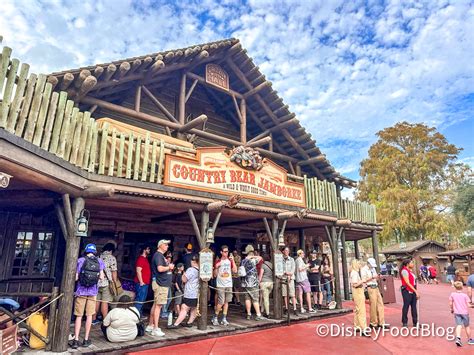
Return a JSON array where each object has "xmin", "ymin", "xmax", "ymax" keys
[{"xmin": 69, "ymin": 244, "xmax": 105, "ymax": 349}]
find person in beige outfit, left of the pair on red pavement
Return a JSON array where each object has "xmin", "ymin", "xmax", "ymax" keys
[{"xmin": 350, "ymin": 259, "xmax": 369, "ymax": 336}]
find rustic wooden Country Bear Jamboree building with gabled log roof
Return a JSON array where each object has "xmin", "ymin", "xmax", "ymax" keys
[{"xmin": 0, "ymin": 39, "xmax": 381, "ymax": 351}]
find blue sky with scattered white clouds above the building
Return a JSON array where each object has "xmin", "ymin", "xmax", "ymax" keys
[{"xmin": 0, "ymin": 0, "xmax": 474, "ymax": 184}]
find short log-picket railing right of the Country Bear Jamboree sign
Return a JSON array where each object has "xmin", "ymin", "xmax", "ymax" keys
[{"xmin": 304, "ymin": 176, "xmax": 377, "ymax": 223}]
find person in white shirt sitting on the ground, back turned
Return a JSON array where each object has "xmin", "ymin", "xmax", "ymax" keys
[{"xmin": 101, "ymin": 295, "xmax": 140, "ymax": 343}]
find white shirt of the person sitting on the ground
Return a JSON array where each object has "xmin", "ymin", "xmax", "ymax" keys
[{"xmin": 103, "ymin": 307, "xmax": 140, "ymax": 343}]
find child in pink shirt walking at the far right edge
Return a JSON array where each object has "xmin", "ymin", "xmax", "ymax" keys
[{"xmin": 449, "ymin": 281, "xmax": 474, "ymax": 347}]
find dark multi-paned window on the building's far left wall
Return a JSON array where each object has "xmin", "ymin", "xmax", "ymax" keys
[{"xmin": 11, "ymin": 231, "xmax": 53, "ymax": 277}]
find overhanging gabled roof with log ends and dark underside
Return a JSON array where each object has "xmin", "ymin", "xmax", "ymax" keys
[{"xmin": 48, "ymin": 38, "xmax": 356, "ymax": 187}]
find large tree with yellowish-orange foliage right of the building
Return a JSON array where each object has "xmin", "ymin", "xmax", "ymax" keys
[{"xmin": 358, "ymin": 122, "xmax": 467, "ymax": 244}]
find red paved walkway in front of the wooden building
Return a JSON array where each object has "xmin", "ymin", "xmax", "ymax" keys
[{"xmin": 130, "ymin": 281, "xmax": 474, "ymax": 355}]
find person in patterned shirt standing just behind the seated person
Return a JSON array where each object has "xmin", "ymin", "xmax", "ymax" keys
[{"xmin": 92, "ymin": 243, "xmax": 117, "ymax": 324}]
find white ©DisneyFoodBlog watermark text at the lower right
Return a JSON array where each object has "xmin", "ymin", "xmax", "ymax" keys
[{"xmin": 316, "ymin": 323, "xmax": 455, "ymax": 341}]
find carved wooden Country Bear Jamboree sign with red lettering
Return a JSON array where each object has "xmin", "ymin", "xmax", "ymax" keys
[{"xmin": 164, "ymin": 147, "xmax": 306, "ymax": 207}]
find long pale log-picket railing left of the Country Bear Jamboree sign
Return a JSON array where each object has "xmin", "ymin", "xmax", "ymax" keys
[{"xmin": 0, "ymin": 47, "xmax": 195, "ymax": 183}]
